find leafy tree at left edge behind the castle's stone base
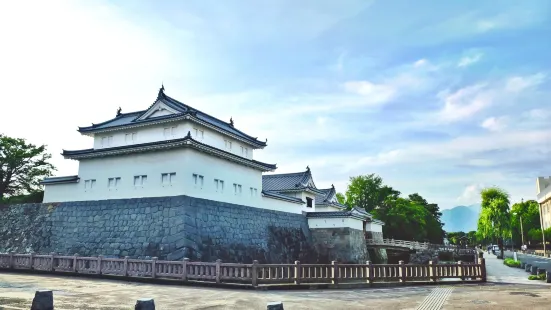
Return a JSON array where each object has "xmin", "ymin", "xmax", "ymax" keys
[{"xmin": 0, "ymin": 135, "xmax": 54, "ymax": 201}]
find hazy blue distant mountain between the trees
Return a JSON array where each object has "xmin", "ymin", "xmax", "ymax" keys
[{"xmin": 440, "ymin": 205, "xmax": 480, "ymax": 232}]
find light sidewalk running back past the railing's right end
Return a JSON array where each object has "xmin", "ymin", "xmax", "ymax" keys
[{"xmin": 484, "ymin": 253, "xmax": 549, "ymax": 285}]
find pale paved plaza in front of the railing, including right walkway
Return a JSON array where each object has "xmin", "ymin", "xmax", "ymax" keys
[{"xmin": 0, "ymin": 255, "xmax": 551, "ymax": 310}]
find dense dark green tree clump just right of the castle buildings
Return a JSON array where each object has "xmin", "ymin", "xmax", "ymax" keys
[{"xmin": 337, "ymin": 174, "xmax": 444, "ymax": 243}]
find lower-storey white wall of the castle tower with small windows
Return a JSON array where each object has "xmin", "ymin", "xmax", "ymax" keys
[{"xmin": 44, "ymin": 149, "xmax": 313, "ymax": 214}]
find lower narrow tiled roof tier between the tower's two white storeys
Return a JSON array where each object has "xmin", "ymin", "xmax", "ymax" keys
[{"xmin": 61, "ymin": 131, "xmax": 277, "ymax": 171}]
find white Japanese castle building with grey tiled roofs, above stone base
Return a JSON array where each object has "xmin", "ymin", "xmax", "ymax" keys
[{"xmin": 42, "ymin": 87, "xmax": 383, "ymax": 232}]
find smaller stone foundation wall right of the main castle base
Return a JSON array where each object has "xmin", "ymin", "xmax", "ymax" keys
[{"xmin": 310, "ymin": 228, "xmax": 369, "ymax": 263}]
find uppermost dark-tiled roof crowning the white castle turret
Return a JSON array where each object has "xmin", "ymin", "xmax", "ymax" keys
[{"xmin": 78, "ymin": 88, "xmax": 266, "ymax": 147}]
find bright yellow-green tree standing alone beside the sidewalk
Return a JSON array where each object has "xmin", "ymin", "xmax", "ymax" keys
[{"xmin": 477, "ymin": 187, "xmax": 511, "ymax": 253}]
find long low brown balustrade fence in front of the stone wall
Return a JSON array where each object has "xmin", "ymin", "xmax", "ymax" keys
[{"xmin": 0, "ymin": 253, "xmax": 486, "ymax": 287}]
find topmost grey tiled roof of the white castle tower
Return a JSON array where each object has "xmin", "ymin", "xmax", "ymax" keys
[{"xmin": 78, "ymin": 87, "xmax": 267, "ymax": 148}]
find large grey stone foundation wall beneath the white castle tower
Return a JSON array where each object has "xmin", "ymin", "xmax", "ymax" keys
[{"xmin": 0, "ymin": 196, "xmax": 316, "ymax": 263}]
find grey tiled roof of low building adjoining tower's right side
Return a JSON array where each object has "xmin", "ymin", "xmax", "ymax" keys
[{"xmin": 262, "ymin": 167, "xmax": 319, "ymax": 193}]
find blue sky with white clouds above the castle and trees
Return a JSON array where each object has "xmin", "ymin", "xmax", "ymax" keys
[{"xmin": 0, "ymin": 0, "xmax": 551, "ymax": 209}]
